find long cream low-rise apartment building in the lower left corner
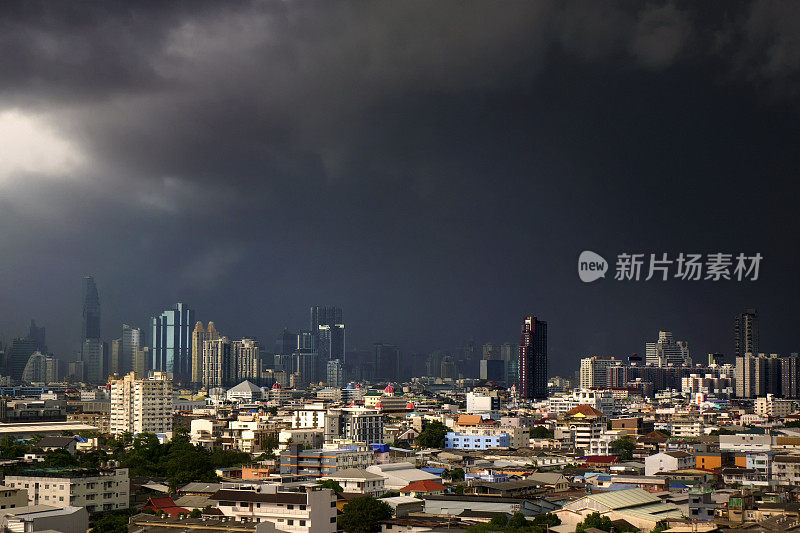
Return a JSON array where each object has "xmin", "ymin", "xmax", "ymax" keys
[{"xmin": 4, "ymin": 468, "xmax": 130, "ymax": 513}]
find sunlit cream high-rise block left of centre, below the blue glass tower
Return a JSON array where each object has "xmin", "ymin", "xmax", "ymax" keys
[{"xmin": 109, "ymin": 372, "xmax": 172, "ymax": 435}]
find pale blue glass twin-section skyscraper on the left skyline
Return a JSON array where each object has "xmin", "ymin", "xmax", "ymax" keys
[{"xmin": 151, "ymin": 303, "xmax": 195, "ymax": 383}]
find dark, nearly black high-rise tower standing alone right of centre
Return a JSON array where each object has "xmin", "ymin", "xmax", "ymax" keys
[{"xmin": 518, "ymin": 316, "xmax": 547, "ymax": 399}]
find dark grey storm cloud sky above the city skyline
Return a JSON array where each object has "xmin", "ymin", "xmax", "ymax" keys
[{"xmin": 0, "ymin": 1, "xmax": 800, "ymax": 371}]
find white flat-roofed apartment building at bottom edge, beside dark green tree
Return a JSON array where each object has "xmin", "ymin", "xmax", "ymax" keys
[{"xmin": 210, "ymin": 483, "xmax": 336, "ymax": 533}]
